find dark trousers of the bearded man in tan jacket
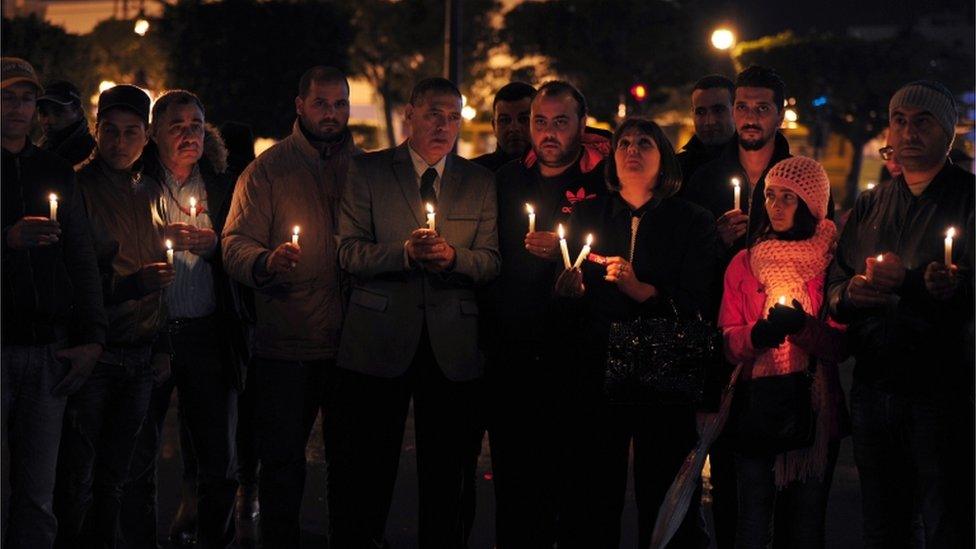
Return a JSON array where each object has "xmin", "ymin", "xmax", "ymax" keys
[{"xmin": 251, "ymin": 357, "xmax": 330, "ymax": 549}]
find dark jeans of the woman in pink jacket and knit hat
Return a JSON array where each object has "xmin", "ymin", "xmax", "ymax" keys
[{"xmin": 735, "ymin": 441, "xmax": 840, "ymax": 549}]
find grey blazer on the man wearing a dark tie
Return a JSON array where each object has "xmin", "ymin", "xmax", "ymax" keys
[{"xmin": 337, "ymin": 144, "xmax": 501, "ymax": 381}]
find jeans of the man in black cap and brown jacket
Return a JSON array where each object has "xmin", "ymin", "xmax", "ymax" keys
[{"xmin": 54, "ymin": 347, "xmax": 153, "ymax": 549}]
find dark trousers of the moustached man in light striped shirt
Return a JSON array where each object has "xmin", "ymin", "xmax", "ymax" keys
[{"xmin": 120, "ymin": 319, "xmax": 237, "ymax": 549}]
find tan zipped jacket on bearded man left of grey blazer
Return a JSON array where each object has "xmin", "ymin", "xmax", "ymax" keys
[{"xmin": 222, "ymin": 120, "xmax": 360, "ymax": 361}]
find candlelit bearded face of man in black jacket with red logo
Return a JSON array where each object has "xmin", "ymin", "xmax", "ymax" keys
[{"xmin": 531, "ymin": 94, "xmax": 586, "ymax": 168}]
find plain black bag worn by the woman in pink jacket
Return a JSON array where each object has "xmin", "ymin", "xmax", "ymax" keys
[{"xmin": 730, "ymin": 357, "xmax": 817, "ymax": 456}]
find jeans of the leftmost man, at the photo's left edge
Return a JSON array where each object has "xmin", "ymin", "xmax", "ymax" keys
[{"xmin": 0, "ymin": 345, "xmax": 68, "ymax": 549}]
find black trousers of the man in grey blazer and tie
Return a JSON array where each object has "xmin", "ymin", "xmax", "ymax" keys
[{"xmin": 326, "ymin": 330, "xmax": 480, "ymax": 549}]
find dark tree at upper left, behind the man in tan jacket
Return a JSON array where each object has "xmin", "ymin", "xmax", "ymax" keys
[{"xmin": 156, "ymin": 0, "xmax": 354, "ymax": 136}]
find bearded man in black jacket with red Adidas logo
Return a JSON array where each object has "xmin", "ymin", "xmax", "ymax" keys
[{"xmin": 483, "ymin": 81, "xmax": 610, "ymax": 547}]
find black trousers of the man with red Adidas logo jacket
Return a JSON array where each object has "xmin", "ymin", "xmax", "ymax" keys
[{"xmin": 485, "ymin": 342, "xmax": 572, "ymax": 549}]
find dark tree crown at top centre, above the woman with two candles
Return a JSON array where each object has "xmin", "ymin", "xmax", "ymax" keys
[{"xmin": 502, "ymin": 0, "xmax": 707, "ymax": 119}]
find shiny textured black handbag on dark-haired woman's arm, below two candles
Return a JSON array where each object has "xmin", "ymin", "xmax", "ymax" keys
[{"xmin": 603, "ymin": 299, "xmax": 722, "ymax": 404}]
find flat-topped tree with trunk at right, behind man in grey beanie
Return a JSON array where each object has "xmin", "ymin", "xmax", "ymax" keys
[{"xmin": 734, "ymin": 30, "xmax": 973, "ymax": 207}]
